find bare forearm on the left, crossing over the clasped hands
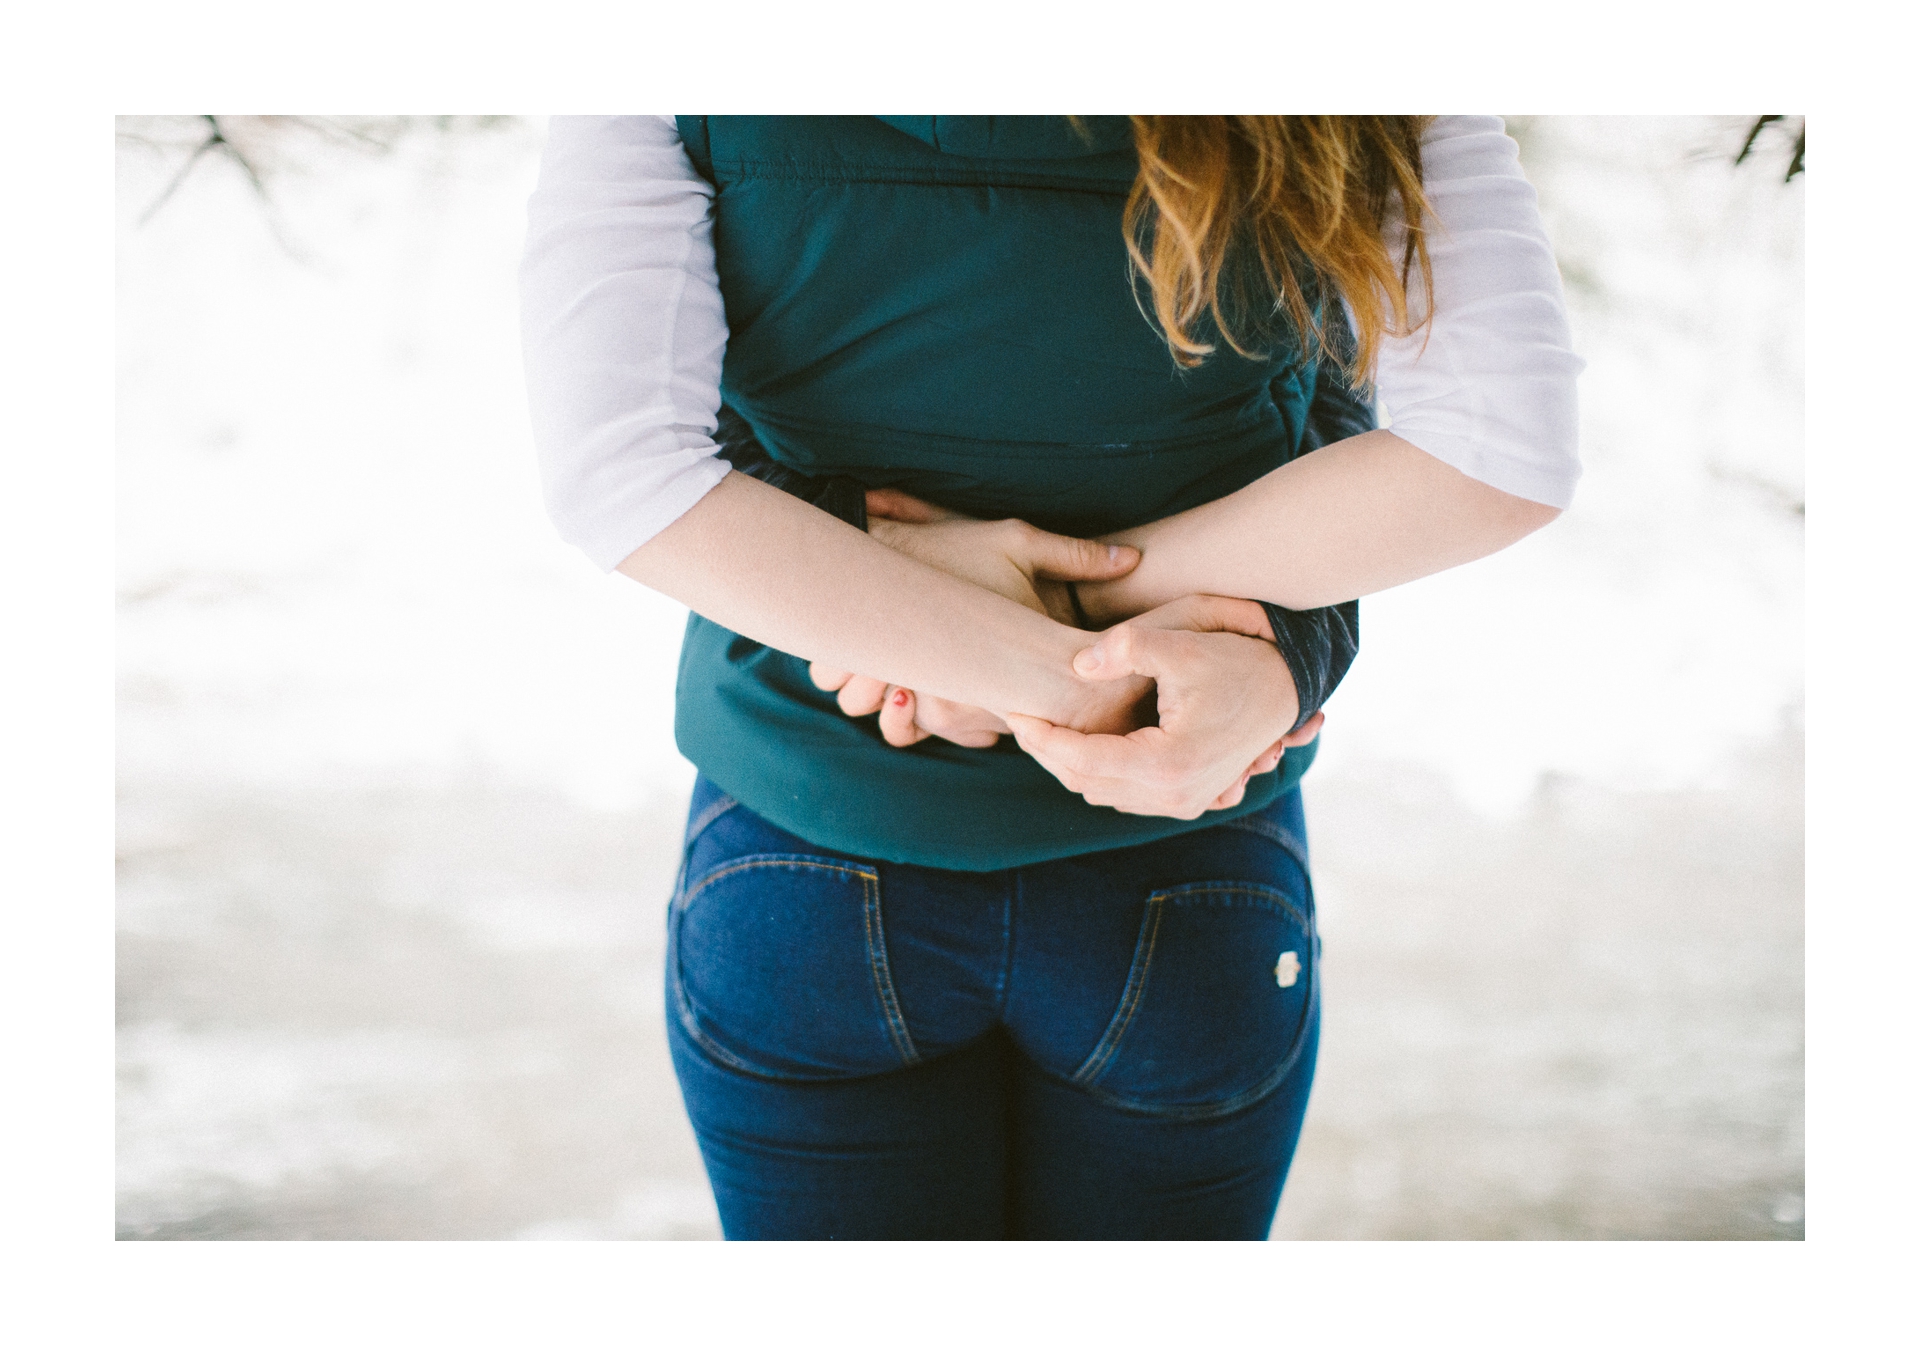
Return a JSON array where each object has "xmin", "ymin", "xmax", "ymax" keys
[{"xmin": 620, "ymin": 474, "xmax": 1091, "ymax": 722}]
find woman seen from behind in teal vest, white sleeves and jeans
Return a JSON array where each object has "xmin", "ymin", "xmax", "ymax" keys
[{"xmin": 524, "ymin": 117, "xmax": 1578, "ymax": 1237}]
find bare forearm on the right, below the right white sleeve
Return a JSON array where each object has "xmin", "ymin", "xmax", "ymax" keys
[{"xmin": 1079, "ymin": 430, "xmax": 1559, "ymax": 624}]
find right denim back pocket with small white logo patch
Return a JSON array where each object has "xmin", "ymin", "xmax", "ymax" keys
[{"xmin": 1073, "ymin": 882, "xmax": 1319, "ymax": 1120}]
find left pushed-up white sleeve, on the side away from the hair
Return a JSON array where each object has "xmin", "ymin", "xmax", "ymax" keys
[{"xmin": 520, "ymin": 117, "xmax": 728, "ymax": 570}]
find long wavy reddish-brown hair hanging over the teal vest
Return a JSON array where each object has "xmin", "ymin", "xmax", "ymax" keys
[{"xmin": 1125, "ymin": 117, "xmax": 1432, "ymax": 380}]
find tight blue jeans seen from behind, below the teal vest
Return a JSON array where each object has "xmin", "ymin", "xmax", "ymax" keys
[{"xmin": 666, "ymin": 778, "xmax": 1319, "ymax": 1239}]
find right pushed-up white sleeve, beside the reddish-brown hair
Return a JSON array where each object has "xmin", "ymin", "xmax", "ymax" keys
[{"xmin": 1375, "ymin": 117, "xmax": 1586, "ymax": 509}]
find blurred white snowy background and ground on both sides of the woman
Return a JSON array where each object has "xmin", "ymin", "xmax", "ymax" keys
[{"xmin": 115, "ymin": 119, "xmax": 1805, "ymax": 1239}]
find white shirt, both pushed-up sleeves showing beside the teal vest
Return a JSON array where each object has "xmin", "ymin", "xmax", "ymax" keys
[{"xmin": 520, "ymin": 117, "xmax": 1582, "ymax": 570}]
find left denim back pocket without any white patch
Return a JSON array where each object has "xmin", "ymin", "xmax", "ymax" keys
[{"xmin": 666, "ymin": 853, "xmax": 920, "ymax": 1079}]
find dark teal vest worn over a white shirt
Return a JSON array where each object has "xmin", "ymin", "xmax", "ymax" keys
[{"xmin": 674, "ymin": 117, "xmax": 1315, "ymax": 870}]
